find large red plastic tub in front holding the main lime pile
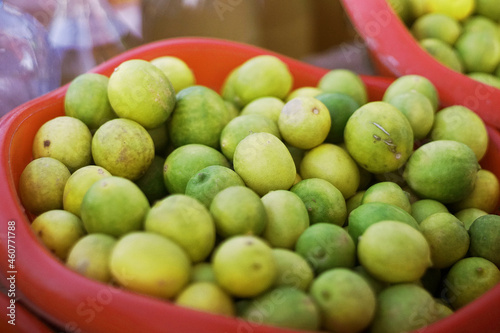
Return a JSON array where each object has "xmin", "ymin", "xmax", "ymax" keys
[{"xmin": 0, "ymin": 38, "xmax": 500, "ymax": 333}]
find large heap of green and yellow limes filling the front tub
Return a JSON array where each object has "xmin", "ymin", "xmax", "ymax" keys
[{"xmin": 19, "ymin": 55, "xmax": 500, "ymax": 333}]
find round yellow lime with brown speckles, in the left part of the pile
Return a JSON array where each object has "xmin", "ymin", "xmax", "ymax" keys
[{"xmin": 92, "ymin": 118, "xmax": 155, "ymax": 181}]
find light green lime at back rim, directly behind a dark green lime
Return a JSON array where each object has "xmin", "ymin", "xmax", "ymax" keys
[{"xmin": 318, "ymin": 69, "xmax": 368, "ymax": 105}]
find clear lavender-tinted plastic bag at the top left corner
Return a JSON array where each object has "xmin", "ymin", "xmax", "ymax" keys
[{"xmin": 0, "ymin": 0, "xmax": 61, "ymax": 117}]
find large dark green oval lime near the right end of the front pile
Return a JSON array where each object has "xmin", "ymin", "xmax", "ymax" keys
[{"xmin": 403, "ymin": 140, "xmax": 479, "ymax": 204}]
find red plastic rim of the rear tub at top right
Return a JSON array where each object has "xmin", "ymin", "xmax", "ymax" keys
[{"xmin": 341, "ymin": 0, "xmax": 500, "ymax": 128}]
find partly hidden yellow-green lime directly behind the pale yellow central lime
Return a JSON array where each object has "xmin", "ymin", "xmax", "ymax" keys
[{"xmin": 220, "ymin": 114, "xmax": 281, "ymax": 161}]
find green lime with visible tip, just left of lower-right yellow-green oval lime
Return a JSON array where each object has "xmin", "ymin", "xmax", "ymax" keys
[{"xmin": 295, "ymin": 223, "xmax": 356, "ymax": 275}]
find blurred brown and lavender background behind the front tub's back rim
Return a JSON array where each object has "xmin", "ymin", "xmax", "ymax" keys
[{"xmin": 0, "ymin": 0, "xmax": 373, "ymax": 116}]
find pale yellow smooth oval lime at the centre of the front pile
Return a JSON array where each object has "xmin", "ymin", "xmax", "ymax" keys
[{"xmin": 233, "ymin": 132, "xmax": 296, "ymax": 196}]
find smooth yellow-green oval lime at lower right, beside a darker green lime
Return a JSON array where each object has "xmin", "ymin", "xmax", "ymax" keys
[{"xmin": 357, "ymin": 221, "xmax": 432, "ymax": 283}]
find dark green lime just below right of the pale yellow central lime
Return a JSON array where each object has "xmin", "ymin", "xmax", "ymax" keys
[{"xmin": 290, "ymin": 178, "xmax": 347, "ymax": 226}]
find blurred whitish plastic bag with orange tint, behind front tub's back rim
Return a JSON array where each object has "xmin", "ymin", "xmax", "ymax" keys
[{"xmin": 49, "ymin": 0, "xmax": 142, "ymax": 84}]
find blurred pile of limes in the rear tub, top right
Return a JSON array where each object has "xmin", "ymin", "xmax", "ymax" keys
[{"xmin": 389, "ymin": 0, "xmax": 500, "ymax": 88}]
